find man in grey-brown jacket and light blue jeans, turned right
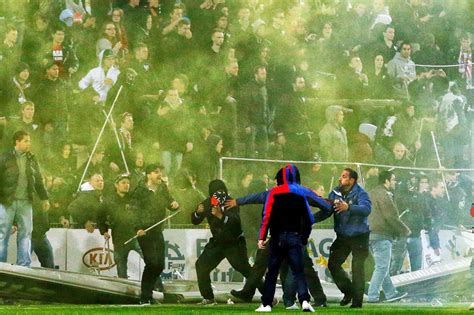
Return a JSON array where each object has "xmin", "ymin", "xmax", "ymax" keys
[{"xmin": 367, "ymin": 171, "xmax": 411, "ymax": 303}]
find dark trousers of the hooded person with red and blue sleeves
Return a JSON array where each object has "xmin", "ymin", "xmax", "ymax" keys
[{"xmin": 262, "ymin": 232, "xmax": 311, "ymax": 306}]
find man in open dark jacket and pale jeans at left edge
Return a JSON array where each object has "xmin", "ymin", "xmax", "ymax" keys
[{"xmin": 0, "ymin": 130, "xmax": 49, "ymax": 266}]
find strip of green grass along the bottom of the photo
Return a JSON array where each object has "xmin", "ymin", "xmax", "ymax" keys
[{"xmin": 0, "ymin": 303, "xmax": 468, "ymax": 315}]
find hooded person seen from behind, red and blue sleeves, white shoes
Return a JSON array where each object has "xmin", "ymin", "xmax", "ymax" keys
[{"xmin": 256, "ymin": 164, "xmax": 329, "ymax": 312}]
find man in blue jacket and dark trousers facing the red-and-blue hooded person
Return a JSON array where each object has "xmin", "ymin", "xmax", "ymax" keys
[{"xmin": 315, "ymin": 168, "xmax": 372, "ymax": 308}]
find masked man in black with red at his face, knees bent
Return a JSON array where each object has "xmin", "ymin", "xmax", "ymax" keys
[{"xmin": 191, "ymin": 179, "xmax": 254, "ymax": 305}]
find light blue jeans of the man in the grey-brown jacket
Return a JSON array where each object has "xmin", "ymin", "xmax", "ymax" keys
[{"xmin": 367, "ymin": 233, "xmax": 398, "ymax": 302}]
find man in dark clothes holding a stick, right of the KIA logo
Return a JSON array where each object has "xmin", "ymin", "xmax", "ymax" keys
[{"xmin": 132, "ymin": 164, "xmax": 179, "ymax": 304}]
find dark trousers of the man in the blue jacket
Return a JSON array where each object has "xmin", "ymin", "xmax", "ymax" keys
[{"xmin": 328, "ymin": 233, "xmax": 369, "ymax": 306}]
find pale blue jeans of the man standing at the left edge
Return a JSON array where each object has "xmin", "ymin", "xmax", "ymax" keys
[{"xmin": 0, "ymin": 200, "xmax": 33, "ymax": 267}]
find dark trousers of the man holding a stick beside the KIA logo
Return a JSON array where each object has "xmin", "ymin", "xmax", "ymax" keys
[{"xmin": 138, "ymin": 231, "xmax": 165, "ymax": 301}]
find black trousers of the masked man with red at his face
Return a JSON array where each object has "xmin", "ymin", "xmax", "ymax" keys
[{"xmin": 196, "ymin": 237, "xmax": 251, "ymax": 300}]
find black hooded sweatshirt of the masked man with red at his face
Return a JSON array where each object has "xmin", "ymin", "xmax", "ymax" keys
[{"xmin": 191, "ymin": 179, "xmax": 243, "ymax": 243}]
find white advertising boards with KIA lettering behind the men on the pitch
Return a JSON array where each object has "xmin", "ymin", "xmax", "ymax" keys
[{"xmin": 8, "ymin": 229, "xmax": 474, "ymax": 282}]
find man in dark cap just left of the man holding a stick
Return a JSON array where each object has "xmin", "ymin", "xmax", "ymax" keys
[{"xmin": 97, "ymin": 174, "xmax": 143, "ymax": 279}]
